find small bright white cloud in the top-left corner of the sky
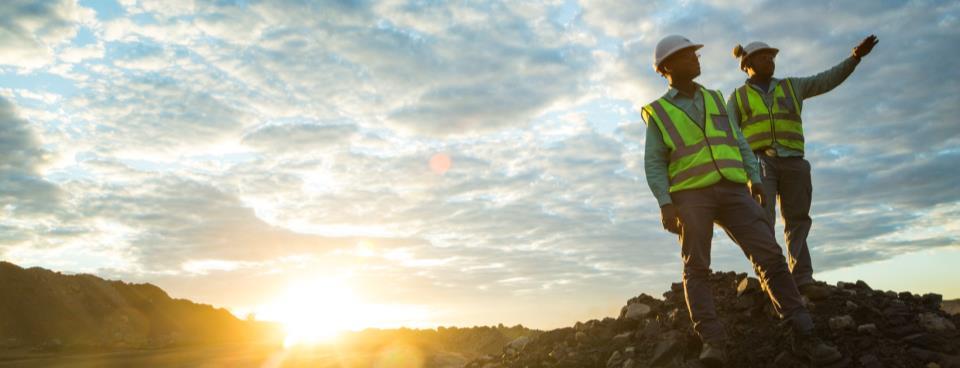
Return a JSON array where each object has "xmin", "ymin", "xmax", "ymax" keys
[{"xmin": 0, "ymin": 0, "xmax": 81, "ymax": 69}]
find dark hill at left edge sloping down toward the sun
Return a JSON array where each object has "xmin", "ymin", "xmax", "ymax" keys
[{"xmin": 0, "ymin": 262, "xmax": 279, "ymax": 351}]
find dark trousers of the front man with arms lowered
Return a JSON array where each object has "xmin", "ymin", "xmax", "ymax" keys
[{"xmin": 671, "ymin": 181, "xmax": 813, "ymax": 343}]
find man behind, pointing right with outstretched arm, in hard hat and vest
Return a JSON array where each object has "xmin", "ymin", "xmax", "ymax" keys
[{"xmin": 727, "ymin": 35, "xmax": 878, "ymax": 300}]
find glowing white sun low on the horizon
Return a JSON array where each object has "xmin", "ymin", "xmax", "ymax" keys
[{"xmin": 264, "ymin": 278, "xmax": 359, "ymax": 348}]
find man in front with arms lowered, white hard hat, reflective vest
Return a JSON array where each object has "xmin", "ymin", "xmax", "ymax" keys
[{"xmin": 641, "ymin": 35, "xmax": 841, "ymax": 367}]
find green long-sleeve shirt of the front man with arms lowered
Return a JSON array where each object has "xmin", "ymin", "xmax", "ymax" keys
[{"xmin": 641, "ymin": 85, "xmax": 760, "ymax": 207}]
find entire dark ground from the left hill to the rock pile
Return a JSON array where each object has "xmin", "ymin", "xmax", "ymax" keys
[{"xmin": 0, "ymin": 262, "xmax": 960, "ymax": 368}]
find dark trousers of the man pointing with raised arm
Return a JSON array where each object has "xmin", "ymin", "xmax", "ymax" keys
[{"xmin": 757, "ymin": 154, "xmax": 813, "ymax": 286}]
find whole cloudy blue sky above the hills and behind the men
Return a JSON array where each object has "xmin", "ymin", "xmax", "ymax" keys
[{"xmin": 0, "ymin": 0, "xmax": 960, "ymax": 329}]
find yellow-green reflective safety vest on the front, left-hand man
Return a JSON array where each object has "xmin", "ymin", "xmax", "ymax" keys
[{"xmin": 643, "ymin": 88, "xmax": 747, "ymax": 193}]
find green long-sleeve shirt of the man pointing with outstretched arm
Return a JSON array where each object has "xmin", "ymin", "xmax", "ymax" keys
[{"xmin": 727, "ymin": 56, "xmax": 860, "ymax": 157}]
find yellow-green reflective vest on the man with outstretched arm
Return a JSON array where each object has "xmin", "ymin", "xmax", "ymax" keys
[{"xmin": 735, "ymin": 79, "xmax": 804, "ymax": 152}]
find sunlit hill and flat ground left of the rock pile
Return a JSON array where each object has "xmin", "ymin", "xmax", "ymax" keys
[{"xmin": 0, "ymin": 262, "xmax": 540, "ymax": 368}]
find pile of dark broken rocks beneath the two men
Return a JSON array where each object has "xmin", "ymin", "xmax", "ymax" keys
[{"xmin": 466, "ymin": 272, "xmax": 960, "ymax": 368}]
